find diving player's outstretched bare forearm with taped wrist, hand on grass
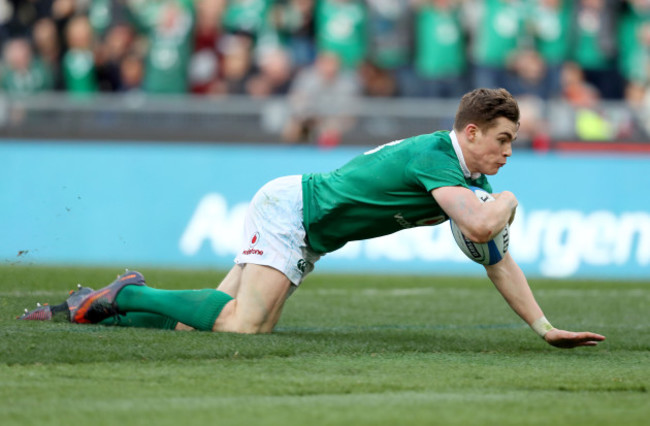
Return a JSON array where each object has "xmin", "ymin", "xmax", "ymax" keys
[{"xmin": 485, "ymin": 253, "xmax": 605, "ymax": 348}]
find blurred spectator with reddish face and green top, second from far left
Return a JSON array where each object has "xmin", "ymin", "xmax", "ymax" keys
[{"xmin": 62, "ymin": 15, "xmax": 98, "ymax": 94}]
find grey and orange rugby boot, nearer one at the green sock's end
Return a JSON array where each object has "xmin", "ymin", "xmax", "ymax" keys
[{"xmin": 70, "ymin": 271, "xmax": 145, "ymax": 324}]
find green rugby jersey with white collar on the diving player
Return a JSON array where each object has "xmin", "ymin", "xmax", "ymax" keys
[{"xmin": 302, "ymin": 131, "xmax": 492, "ymax": 253}]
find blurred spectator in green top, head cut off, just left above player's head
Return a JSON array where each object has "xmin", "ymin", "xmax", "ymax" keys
[{"xmin": 404, "ymin": 0, "xmax": 467, "ymax": 98}]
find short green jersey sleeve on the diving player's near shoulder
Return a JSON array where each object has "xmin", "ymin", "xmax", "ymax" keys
[{"xmin": 406, "ymin": 152, "xmax": 467, "ymax": 192}]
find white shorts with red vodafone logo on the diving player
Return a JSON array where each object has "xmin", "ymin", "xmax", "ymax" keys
[{"xmin": 235, "ymin": 175, "xmax": 320, "ymax": 286}]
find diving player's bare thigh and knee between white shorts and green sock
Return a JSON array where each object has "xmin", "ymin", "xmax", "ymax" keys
[{"xmin": 214, "ymin": 263, "xmax": 291, "ymax": 333}]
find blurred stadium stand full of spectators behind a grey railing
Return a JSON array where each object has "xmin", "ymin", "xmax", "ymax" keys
[{"xmin": 0, "ymin": 0, "xmax": 650, "ymax": 150}]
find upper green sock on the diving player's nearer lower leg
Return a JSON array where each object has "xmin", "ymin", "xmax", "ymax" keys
[{"xmin": 115, "ymin": 285, "xmax": 233, "ymax": 331}]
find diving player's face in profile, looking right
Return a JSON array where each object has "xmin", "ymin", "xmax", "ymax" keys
[{"xmin": 472, "ymin": 117, "xmax": 518, "ymax": 175}]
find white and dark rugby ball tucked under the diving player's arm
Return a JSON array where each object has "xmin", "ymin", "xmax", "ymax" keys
[{"xmin": 449, "ymin": 186, "xmax": 510, "ymax": 265}]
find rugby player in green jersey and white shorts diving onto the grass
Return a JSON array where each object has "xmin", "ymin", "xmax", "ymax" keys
[{"xmin": 20, "ymin": 89, "xmax": 605, "ymax": 348}]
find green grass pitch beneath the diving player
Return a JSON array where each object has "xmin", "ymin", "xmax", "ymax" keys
[{"xmin": 0, "ymin": 266, "xmax": 650, "ymax": 425}]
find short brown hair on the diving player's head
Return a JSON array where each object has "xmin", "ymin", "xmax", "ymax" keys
[{"xmin": 454, "ymin": 89, "xmax": 519, "ymax": 131}]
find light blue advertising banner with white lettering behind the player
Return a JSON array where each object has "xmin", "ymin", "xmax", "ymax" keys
[{"xmin": 0, "ymin": 141, "xmax": 650, "ymax": 279}]
